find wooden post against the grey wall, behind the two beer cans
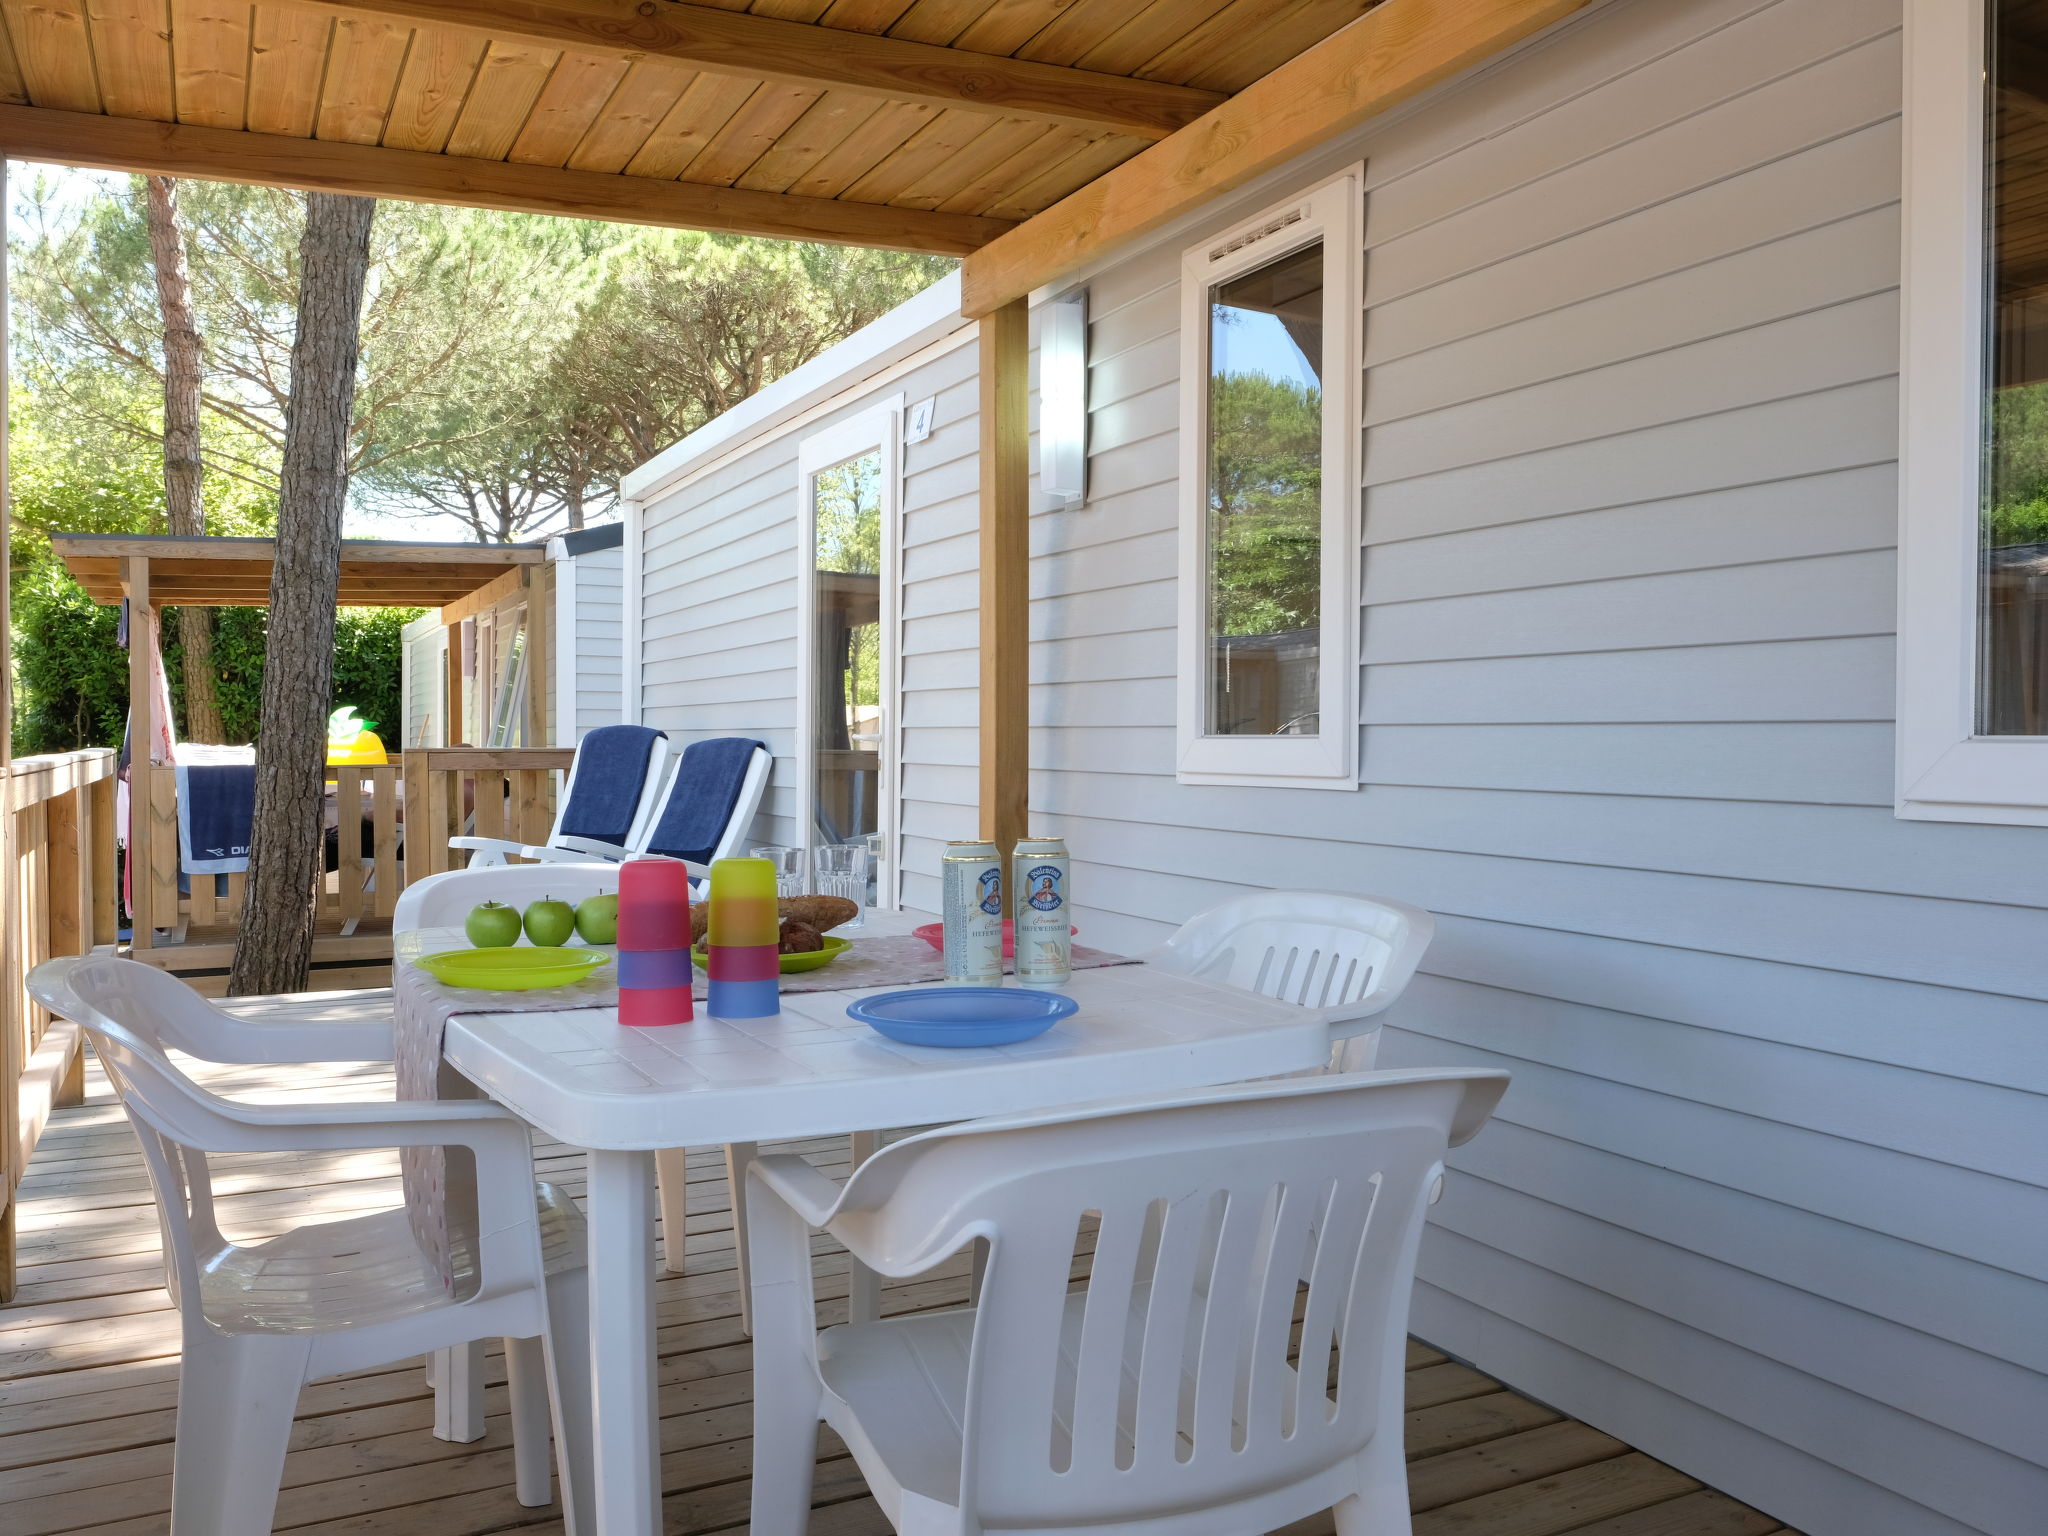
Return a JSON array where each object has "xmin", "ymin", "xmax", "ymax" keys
[{"xmin": 981, "ymin": 299, "xmax": 1030, "ymax": 856}]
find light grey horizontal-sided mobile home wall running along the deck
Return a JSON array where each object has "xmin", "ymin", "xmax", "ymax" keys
[{"xmin": 625, "ymin": 0, "xmax": 2048, "ymax": 1536}]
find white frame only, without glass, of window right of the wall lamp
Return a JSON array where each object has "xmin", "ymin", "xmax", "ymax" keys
[{"xmin": 1174, "ymin": 166, "xmax": 1364, "ymax": 791}]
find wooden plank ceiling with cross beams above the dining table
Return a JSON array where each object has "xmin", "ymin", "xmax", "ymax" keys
[{"xmin": 0, "ymin": 0, "xmax": 1378, "ymax": 254}]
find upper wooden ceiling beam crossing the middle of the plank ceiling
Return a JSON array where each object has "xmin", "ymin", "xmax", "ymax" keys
[{"xmin": 301, "ymin": 0, "xmax": 1227, "ymax": 139}]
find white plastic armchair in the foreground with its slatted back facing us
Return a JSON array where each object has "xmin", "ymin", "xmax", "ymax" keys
[{"xmin": 748, "ymin": 1071, "xmax": 1507, "ymax": 1536}]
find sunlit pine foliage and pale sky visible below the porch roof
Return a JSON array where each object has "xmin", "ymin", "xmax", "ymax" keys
[{"xmin": 10, "ymin": 166, "xmax": 950, "ymax": 539}]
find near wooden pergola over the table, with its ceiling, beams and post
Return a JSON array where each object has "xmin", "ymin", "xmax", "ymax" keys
[{"xmin": 0, "ymin": 0, "xmax": 1589, "ymax": 860}]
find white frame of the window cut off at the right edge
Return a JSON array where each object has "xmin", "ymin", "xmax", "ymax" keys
[{"xmin": 1894, "ymin": 0, "xmax": 2048, "ymax": 825}]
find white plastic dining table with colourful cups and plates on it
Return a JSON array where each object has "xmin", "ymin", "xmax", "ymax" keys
[{"xmin": 395, "ymin": 913, "xmax": 1378, "ymax": 1536}]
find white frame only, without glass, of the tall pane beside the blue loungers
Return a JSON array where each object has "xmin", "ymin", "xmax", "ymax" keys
[{"xmin": 795, "ymin": 393, "xmax": 903, "ymax": 911}]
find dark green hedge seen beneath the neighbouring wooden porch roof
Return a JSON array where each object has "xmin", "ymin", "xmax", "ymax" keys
[{"xmin": 14, "ymin": 563, "xmax": 422, "ymax": 754}]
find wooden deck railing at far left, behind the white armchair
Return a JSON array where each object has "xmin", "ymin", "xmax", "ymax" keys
[{"xmin": 0, "ymin": 748, "xmax": 115, "ymax": 1300}]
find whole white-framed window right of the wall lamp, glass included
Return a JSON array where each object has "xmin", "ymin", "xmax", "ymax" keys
[{"xmin": 1176, "ymin": 170, "xmax": 1364, "ymax": 788}]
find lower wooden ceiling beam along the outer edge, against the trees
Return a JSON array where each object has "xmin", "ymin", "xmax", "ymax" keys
[{"xmin": 0, "ymin": 107, "xmax": 1016, "ymax": 256}]
